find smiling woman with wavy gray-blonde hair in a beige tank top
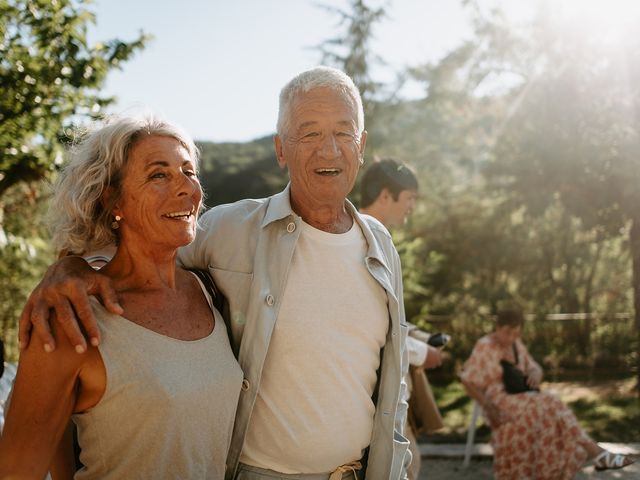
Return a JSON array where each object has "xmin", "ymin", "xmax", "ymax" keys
[{"xmin": 0, "ymin": 115, "xmax": 242, "ymax": 479}]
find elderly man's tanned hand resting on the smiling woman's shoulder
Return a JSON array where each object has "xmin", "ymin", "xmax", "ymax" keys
[{"xmin": 18, "ymin": 256, "xmax": 123, "ymax": 353}]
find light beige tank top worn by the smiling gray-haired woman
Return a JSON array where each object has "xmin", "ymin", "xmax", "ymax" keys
[{"xmin": 72, "ymin": 278, "xmax": 242, "ymax": 480}]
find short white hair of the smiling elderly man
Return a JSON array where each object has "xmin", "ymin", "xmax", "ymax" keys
[{"xmin": 276, "ymin": 66, "xmax": 364, "ymax": 137}]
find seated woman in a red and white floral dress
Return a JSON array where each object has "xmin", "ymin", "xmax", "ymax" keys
[{"xmin": 461, "ymin": 310, "xmax": 633, "ymax": 480}]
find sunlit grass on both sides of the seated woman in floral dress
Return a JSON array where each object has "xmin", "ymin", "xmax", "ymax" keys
[{"xmin": 420, "ymin": 378, "xmax": 640, "ymax": 443}]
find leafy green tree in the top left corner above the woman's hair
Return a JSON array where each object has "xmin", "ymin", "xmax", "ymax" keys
[{"xmin": 0, "ymin": 0, "xmax": 148, "ymax": 198}]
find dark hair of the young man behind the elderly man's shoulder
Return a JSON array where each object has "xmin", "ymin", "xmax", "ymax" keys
[{"xmin": 360, "ymin": 158, "xmax": 418, "ymax": 208}]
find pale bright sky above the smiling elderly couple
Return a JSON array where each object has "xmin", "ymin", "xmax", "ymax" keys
[{"xmin": 89, "ymin": 0, "xmax": 478, "ymax": 141}]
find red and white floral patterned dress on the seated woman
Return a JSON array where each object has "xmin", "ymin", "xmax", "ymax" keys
[{"xmin": 461, "ymin": 335, "xmax": 590, "ymax": 480}]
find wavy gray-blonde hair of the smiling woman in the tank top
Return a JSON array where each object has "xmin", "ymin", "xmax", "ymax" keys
[{"xmin": 47, "ymin": 112, "xmax": 199, "ymax": 254}]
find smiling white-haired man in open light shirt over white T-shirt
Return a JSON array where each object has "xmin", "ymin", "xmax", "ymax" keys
[{"xmin": 21, "ymin": 67, "xmax": 411, "ymax": 480}]
